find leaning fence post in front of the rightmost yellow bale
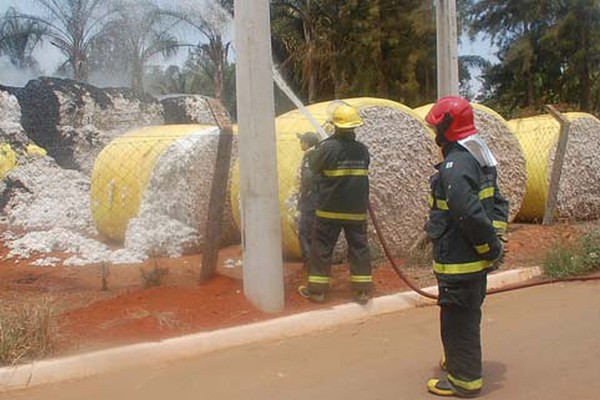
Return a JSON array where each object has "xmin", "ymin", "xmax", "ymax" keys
[{"xmin": 542, "ymin": 105, "xmax": 571, "ymax": 225}]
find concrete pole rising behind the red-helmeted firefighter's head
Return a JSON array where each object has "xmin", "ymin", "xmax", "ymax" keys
[{"xmin": 436, "ymin": 0, "xmax": 458, "ymax": 98}]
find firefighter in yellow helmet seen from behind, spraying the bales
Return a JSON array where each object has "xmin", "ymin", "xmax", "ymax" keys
[{"xmin": 298, "ymin": 102, "xmax": 373, "ymax": 304}]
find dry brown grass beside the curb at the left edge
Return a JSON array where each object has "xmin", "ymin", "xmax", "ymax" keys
[{"xmin": 0, "ymin": 300, "xmax": 55, "ymax": 366}]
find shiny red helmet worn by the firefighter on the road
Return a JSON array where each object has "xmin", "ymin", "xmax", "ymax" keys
[{"xmin": 425, "ymin": 96, "xmax": 477, "ymax": 142}]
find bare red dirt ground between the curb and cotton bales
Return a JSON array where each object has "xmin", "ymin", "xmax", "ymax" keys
[{"xmin": 0, "ymin": 224, "xmax": 584, "ymax": 356}]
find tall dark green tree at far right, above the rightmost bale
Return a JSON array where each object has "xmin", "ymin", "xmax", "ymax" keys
[{"xmin": 469, "ymin": 0, "xmax": 600, "ymax": 115}]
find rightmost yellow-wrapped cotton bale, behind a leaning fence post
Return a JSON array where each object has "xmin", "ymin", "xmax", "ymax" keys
[{"xmin": 508, "ymin": 113, "xmax": 600, "ymax": 221}]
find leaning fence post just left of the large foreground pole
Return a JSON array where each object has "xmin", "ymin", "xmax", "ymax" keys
[{"xmin": 200, "ymin": 99, "xmax": 233, "ymax": 282}]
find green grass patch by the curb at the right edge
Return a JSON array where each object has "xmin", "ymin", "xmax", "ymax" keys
[{"xmin": 543, "ymin": 229, "xmax": 600, "ymax": 278}]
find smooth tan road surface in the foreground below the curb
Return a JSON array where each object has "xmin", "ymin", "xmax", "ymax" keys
[{"xmin": 0, "ymin": 283, "xmax": 600, "ymax": 400}]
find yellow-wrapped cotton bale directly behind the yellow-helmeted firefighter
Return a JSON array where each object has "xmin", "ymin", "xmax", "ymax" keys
[{"xmin": 232, "ymin": 98, "xmax": 437, "ymax": 258}]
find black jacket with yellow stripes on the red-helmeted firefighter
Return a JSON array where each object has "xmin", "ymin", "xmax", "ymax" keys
[{"xmin": 426, "ymin": 143, "xmax": 508, "ymax": 280}]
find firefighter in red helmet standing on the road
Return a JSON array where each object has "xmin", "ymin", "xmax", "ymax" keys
[{"xmin": 425, "ymin": 96, "xmax": 508, "ymax": 397}]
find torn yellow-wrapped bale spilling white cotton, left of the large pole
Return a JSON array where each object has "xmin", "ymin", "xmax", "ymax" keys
[{"xmin": 91, "ymin": 125, "xmax": 237, "ymax": 255}]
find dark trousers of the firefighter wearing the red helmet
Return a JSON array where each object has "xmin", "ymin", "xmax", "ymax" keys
[{"xmin": 438, "ymin": 274, "xmax": 487, "ymax": 394}]
